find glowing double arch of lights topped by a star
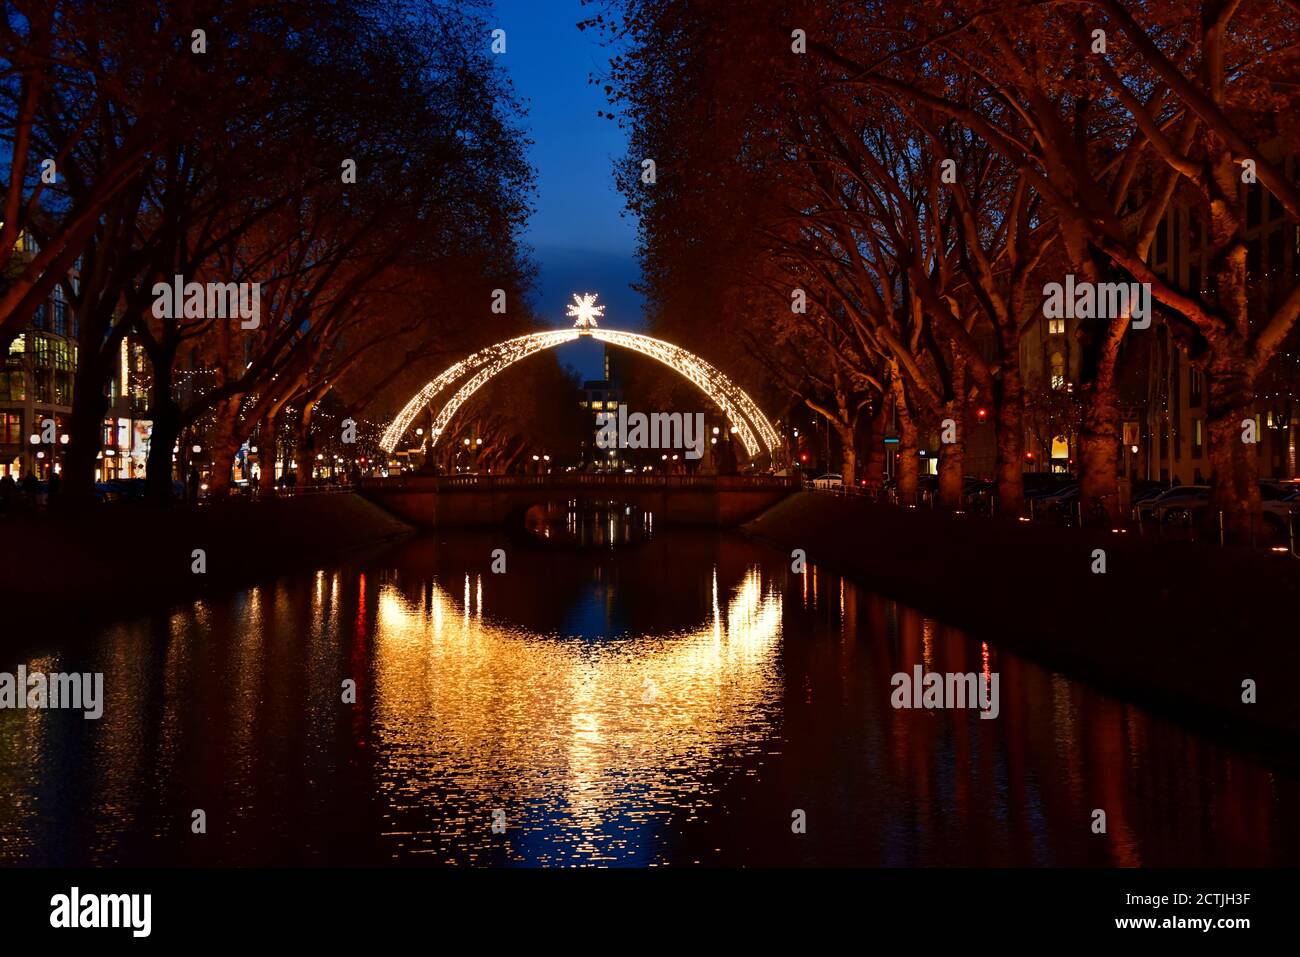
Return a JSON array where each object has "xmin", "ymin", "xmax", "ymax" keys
[{"xmin": 380, "ymin": 296, "xmax": 781, "ymax": 458}]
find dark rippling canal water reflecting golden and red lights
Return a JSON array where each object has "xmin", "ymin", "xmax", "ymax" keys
[{"xmin": 0, "ymin": 512, "xmax": 1300, "ymax": 866}]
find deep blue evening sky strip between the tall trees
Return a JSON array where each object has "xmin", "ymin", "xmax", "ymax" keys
[{"xmin": 486, "ymin": 0, "xmax": 642, "ymax": 378}]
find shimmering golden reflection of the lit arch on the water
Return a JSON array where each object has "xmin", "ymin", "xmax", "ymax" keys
[{"xmin": 374, "ymin": 566, "xmax": 781, "ymax": 861}]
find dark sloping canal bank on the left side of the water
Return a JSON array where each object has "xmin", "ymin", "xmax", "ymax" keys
[{"xmin": 0, "ymin": 494, "xmax": 411, "ymax": 622}]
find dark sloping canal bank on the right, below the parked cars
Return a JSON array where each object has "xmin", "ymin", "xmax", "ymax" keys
[{"xmin": 745, "ymin": 493, "xmax": 1300, "ymax": 745}]
